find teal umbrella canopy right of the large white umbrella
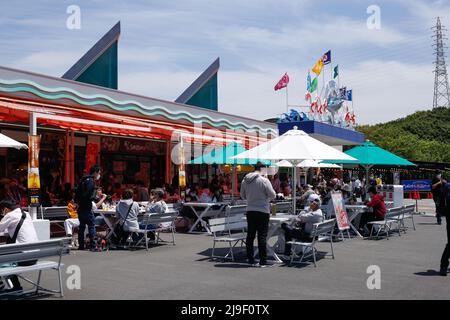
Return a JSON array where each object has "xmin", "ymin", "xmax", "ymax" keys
[{"xmin": 322, "ymin": 141, "xmax": 415, "ymax": 166}]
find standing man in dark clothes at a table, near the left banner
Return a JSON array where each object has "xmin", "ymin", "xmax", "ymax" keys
[{"xmin": 75, "ymin": 165, "xmax": 101, "ymax": 251}]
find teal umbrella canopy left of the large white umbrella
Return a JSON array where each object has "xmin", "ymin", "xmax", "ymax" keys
[{"xmin": 188, "ymin": 142, "xmax": 271, "ymax": 165}]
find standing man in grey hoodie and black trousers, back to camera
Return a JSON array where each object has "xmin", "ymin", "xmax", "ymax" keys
[{"xmin": 241, "ymin": 162, "xmax": 276, "ymax": 268}]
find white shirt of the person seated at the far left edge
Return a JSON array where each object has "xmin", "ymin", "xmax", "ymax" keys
[{"xmin": 0, "ymin": 208, "xmax": 39, "ymax": 243}]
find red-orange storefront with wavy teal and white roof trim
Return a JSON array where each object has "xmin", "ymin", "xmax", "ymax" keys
[{"xmin": 0, "ymin": 67, "xmax": 277, "ymax": 195}]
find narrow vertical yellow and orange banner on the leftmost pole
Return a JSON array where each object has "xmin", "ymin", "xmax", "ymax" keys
[{"xmin": 28, "ymin": 135, "xmax": 41, "ymax": 207}]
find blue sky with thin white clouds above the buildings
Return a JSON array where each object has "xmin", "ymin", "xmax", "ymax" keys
[{"xmin": 0, "ymin": 0, "xmax": 450, "ymax": 124}]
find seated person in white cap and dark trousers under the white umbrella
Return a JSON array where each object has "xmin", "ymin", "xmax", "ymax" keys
[{"xmin": 281, "ymin": 194, "xmax": 323, "ymax": 256}]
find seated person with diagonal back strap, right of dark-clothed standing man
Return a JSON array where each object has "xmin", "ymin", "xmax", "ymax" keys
[{"xmin": 116, "ymin": 189, "xmax": 139, "ymax": 244}]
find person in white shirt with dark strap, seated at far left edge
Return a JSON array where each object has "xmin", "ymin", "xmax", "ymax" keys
[{"xmin": 0, "ymin": 200, "xmax": 39, "ymax": 293}]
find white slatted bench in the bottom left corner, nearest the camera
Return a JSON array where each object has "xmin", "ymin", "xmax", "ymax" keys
[{"xmin": 0, "ymin": 238, "xmax": 72, "ymax": 297}]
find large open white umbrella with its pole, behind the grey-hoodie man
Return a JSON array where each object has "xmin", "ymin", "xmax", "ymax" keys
[{"xmin": 232, "ymin": 127, "xmax": 356, "ymax": 213}]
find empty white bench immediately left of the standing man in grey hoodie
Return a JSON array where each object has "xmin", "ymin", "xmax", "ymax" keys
[{"xmin": 209, "ymin": 214, "xmax": 247, "ymax": 261}]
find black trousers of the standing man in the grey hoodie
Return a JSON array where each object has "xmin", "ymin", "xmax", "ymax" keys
[{"xmin": 246, "ymin": 211, "xmax": 270, "ymax": 264}]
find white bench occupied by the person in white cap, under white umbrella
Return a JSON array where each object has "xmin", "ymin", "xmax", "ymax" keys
[{"xmin": 287, "ymin": 219, "xmax": 336, "ymax": 267}]
